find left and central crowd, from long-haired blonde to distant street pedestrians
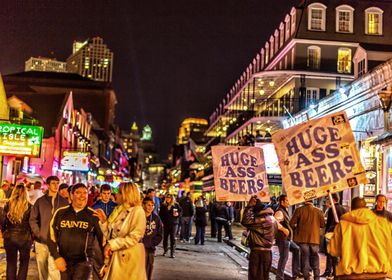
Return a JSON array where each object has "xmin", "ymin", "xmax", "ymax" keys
[{"xmin": 0, "ymin": 176, "xmax": 239, "ymax": 280}]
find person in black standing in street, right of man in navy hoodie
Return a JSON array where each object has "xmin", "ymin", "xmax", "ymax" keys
[{"xmin": 159, "ymin": 194, "xmax": 182, "ymax": 258}]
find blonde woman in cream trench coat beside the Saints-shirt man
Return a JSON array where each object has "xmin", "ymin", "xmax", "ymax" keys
[{"xmin": 97, "ymin": 183, "xmax": 147, "ymax": 280}]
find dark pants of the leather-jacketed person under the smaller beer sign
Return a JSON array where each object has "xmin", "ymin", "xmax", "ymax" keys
[{"xmin": 248, "ymin": 250, "xmax": 272, "ymax": 280}]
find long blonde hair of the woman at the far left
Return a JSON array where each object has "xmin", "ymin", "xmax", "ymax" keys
[{"xmin": 7, "ymin": 184, "xmax": 29, "ymax": 224}]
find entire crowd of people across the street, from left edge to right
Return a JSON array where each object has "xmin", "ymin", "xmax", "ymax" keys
[{"xmin": 0, "ymin": 176, "xmax": 392, "ymax": 280}]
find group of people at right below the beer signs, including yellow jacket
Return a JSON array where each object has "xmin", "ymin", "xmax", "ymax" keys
[{"xmin": 241, "ymin": 193, "xmax": 392, "ymax": 280}]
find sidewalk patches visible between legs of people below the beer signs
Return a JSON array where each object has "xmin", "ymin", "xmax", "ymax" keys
[{"xmin": 225, "ymin": 223, "xmax": 327, "ymax": 277}]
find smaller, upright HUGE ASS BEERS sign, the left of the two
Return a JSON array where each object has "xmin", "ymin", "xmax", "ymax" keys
[{"xmin": 211, "ymin": 146, "xmax": 270, "ymax": 202}]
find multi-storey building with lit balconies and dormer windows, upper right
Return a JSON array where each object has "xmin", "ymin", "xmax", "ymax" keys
[{"xmin": 206, "ymin": 0, "xmax": 392, "ymax": 197}]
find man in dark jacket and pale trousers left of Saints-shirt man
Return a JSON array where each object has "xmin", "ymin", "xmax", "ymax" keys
[{"xmin": 29, "ymin": 176, "xmax": 68, "ymax": 280}]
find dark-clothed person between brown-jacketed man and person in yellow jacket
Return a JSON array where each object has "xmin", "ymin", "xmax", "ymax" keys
[{"xmin": 321, "ymin": 193, "xmax": 347, "ymax": 278}]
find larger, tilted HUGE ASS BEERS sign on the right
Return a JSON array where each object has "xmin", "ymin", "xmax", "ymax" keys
[{"xmin": 272, "ymin": 112, "xmax": 368, "ymax": 204}]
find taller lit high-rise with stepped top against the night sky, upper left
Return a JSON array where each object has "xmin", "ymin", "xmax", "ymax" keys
[{"xmin": 67, "ymin": 37, "xmax": 113, "ymax": 82}]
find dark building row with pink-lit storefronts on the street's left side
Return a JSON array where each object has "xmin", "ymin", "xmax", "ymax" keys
[{"xmin": 0, "ymin": 71, "xmax": 125, "ymax": 186}]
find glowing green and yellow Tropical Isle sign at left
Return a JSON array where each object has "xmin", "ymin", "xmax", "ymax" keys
[{"xmin": 0, "ymin": 123, "xmax": 44, "ymax": 157}]
